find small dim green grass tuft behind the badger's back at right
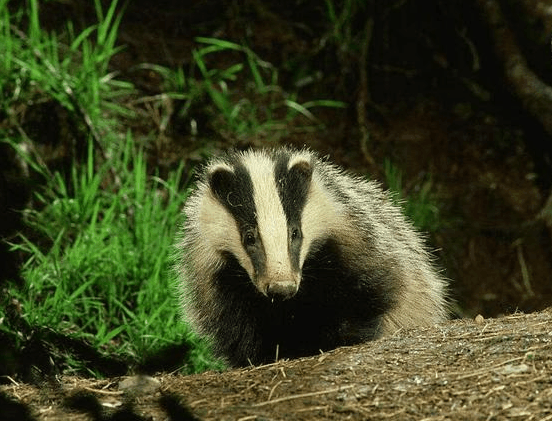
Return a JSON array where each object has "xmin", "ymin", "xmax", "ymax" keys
[{"xmin": 384, "ymin": 160, "xmax": 441, "ymax": 232}]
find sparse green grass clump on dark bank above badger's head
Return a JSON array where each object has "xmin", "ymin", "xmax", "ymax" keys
[{"xmin": 142, "ymin": 37, "xmax": 345, "ymax": 139}]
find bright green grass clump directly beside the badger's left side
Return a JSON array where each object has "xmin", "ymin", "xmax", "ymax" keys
[{"xmin": 2, "ymin": 137, "xmax": 222, "ymax": 372}]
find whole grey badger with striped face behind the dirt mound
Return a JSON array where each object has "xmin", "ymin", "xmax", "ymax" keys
[{"xmin": 176, "ymin": 147, "xmax": 447, "ymax": 366}]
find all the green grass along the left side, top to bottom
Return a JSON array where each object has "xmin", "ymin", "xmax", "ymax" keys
[{"xmin": 0, "ymin": 0, "xmax": 226, "ymax": 375}]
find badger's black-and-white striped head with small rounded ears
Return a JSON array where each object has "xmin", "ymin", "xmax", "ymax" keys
[{"xmin": 200, "ymin": 151, "xmax": 313, "ymax": 299}]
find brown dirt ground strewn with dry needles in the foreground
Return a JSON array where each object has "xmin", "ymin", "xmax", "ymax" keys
[{"xmin": 4, "ymin": 308, "xmax": 552, "ymax": 420}]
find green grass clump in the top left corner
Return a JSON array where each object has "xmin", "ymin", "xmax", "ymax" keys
[{"xmin": 0, "ymin": 0, "xmax": 133, "ymax": 148}]
